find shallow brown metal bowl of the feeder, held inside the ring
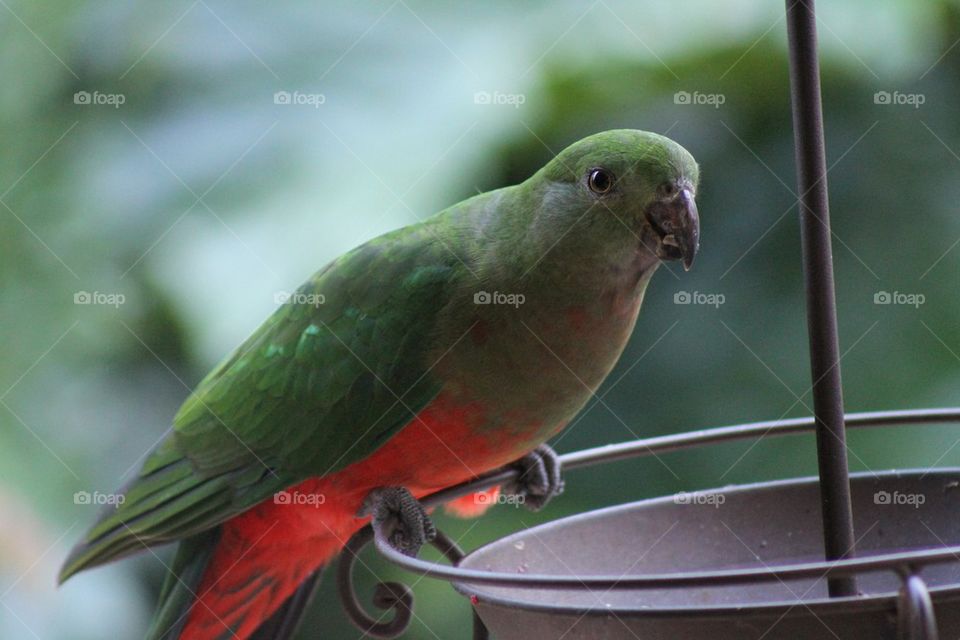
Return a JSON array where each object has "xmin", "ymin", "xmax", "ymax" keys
[{"xmin": 454, "ymin": 469, "xmax": 960, "ymax": 640}]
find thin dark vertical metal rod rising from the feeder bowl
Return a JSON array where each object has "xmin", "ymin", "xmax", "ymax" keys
[{"xmin": 786, "ymin": 0, "xmax": 857, "ymax": 596}]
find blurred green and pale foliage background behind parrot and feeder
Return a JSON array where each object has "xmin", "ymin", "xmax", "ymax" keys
[{"xmin": 0, "ymin": 0, "xmax": 960, "ymax": 640}]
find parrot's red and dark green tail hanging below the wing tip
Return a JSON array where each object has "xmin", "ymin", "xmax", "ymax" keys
[{"xmin": 146, "ymin": 522, "xmax": 341, "ymax": 640}]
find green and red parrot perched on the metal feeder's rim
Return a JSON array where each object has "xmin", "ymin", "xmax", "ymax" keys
[{"xmin": 60, "ymin": 129, "xmax": 700, "ymax": 640}]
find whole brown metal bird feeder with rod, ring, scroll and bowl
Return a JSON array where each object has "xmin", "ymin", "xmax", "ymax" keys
[{"xmin": 338, "ymin": 0, "xmax": 960, "ymax": 640}]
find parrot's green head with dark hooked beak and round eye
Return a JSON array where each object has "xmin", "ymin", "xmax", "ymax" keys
[{"xmin": 534, "ymin": 129, "xmax": 700, "ymax": 269}]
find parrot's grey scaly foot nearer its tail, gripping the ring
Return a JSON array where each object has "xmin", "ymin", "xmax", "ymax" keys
[{"xmin": 359, "ymin": 487, "xmax": 437, "ymax": 557}]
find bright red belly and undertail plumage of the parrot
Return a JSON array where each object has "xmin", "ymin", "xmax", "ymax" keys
[{"xmin": 182, "ymin": 394, "xmax": 542, "ymax": 640}]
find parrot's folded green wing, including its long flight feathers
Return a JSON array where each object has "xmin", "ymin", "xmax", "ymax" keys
[{"xmin": 60, "ymin": 222, "xmax": 462, "ymax": 581}]
